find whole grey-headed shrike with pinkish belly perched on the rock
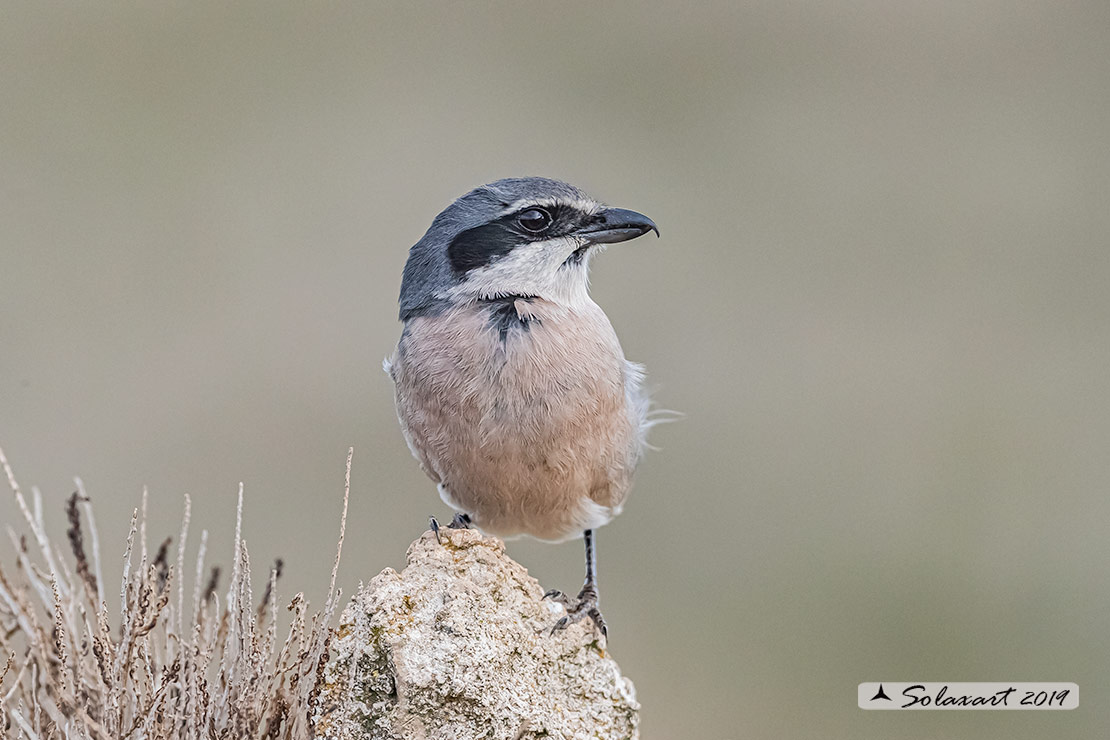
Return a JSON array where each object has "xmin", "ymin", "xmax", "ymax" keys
[{"xmin": 384, "ymin": 178, "xmax": 659, "ymax": 638}]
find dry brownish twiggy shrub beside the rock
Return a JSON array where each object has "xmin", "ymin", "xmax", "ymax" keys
[{"xmin": 0, "ymin": 450, "xmax": 353, "ymax": 740}]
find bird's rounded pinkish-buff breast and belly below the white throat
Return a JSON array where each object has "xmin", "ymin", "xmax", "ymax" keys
[{"xmin": 391, "ymin": 300, "xmax": 646, "ymax": 540}]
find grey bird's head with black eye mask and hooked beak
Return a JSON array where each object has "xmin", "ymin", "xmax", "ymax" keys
[{"xmin": 401, "ymin": 178, "xmax": 659, "ymax": 320}]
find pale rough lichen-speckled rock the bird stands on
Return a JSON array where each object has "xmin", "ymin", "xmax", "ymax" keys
[{"xmin": 314, "ymin": 529, "xmax": 639, "ymax": 740}]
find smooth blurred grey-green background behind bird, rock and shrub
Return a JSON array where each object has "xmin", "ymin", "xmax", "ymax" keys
[{"xmin": 0, "ymin": 0, "xmax": 1110, "ymax": 739}]
